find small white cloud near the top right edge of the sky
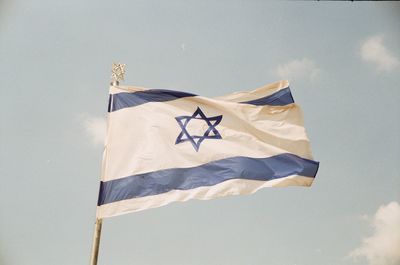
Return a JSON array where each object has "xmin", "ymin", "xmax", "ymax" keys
[{"xmin": 360, "ymin": 36, "xmax": 399, "ymax": 72}]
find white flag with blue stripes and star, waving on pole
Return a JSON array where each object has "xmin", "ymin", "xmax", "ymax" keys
[{"xmin": 97, "ymin": 81, "xmax": 319, "ymax": 218}]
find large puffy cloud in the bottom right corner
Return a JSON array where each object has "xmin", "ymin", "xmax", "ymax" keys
[{"xmin": 350, "ymin": 202, "xmax": 400, "ymax": 265}]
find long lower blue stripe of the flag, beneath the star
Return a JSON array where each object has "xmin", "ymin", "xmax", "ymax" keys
[{"xmin": 97, "ymin": 154, "xmax": 319, "ymax": 206}]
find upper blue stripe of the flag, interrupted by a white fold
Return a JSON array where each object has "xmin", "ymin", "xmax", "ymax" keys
[{"xmin": 108, "ymin": 87, "xmax": 294, "ymax": 112}]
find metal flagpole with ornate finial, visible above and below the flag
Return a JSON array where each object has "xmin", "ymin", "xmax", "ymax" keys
[{"xmin": 90, "ymin": 63, "xmax": 125, "ymax": 265}]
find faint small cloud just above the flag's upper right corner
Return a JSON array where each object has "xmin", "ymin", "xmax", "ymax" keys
[{"xmin": 273, "ymin": 58, "xmax": 321, "ymax": 81}]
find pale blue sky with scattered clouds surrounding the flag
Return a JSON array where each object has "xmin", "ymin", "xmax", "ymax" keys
[{"xmin": 0, "ymin": 0, "xmax": 400, "ymax": 265}]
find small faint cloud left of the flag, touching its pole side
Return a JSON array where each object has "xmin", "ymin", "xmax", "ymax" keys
[{"xmin": 81, "ymin": 114, "xmax": 107, "ymax": 146}]
